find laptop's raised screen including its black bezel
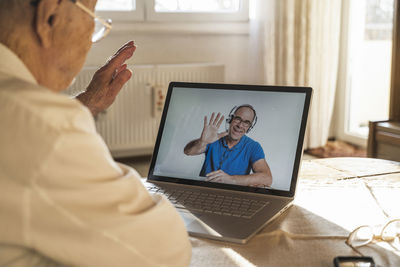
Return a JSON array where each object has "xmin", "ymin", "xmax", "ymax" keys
[{"xmin": 149, "ymin": 82, "xmax": 311, "ymax": 196}]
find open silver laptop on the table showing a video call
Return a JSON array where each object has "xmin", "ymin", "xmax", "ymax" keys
[{"xmin": 145, "ymin": 82, "xmax": 312, "ymax": 244}]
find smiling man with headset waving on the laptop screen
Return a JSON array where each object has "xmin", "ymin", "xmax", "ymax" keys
[{"xmin": 184, "ymin": 104, "xmax": 272, "ymax": 187}]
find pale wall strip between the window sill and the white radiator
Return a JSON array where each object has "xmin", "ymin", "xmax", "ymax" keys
[{"xmin": 86, "ymin": 22, "xmax": 264, "ymax": 84}]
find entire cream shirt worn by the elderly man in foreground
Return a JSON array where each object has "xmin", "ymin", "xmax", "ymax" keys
[{"xmin": 0, "ymin": 44, "xmax": 191, "ymax": 266}]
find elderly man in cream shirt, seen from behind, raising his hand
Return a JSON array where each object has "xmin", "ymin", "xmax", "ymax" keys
[{"xmin": 0, "ymin": 0, "xmax": 191, "ymax": 266}]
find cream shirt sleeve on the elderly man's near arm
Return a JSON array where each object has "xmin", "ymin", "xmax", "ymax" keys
[{"xmin": 26, "ymin": 109, "xmax": 191, "ymax": 267}]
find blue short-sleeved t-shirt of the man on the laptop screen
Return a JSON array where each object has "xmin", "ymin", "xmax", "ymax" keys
[{"xmin": 200, "ymin": 135, "xmax": 265, "ymax": 176}]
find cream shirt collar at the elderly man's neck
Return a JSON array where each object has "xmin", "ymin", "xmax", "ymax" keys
[{"xmin": 0, "ymin": 43, "xmax": 37, "ymax": 84}]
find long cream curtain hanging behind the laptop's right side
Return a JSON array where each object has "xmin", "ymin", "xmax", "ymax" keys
[{"xmin": 256, "ymin": 0, "xmax": 342, "ymax": 148}]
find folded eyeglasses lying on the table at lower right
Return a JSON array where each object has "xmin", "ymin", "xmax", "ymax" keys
[{"xmin": 346, "ymin": 219, "xmax": 400, "ymax": 256}]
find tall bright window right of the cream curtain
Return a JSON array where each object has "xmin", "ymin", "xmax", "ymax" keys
[{"xmin": 342, "ymin": 0, "xmax": 394, "ymax": 147}]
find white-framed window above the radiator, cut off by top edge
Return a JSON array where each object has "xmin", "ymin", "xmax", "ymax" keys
[{"xmin": 96, "ymin": 0, "xmax": 249, "ymax": 22}]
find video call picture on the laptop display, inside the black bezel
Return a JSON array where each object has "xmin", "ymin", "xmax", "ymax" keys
[{"xmin": 153, "ymin": 87, "xmax": 306, "ymax": 194}]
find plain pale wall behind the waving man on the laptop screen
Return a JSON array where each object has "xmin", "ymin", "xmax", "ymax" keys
[{"xmin": 154, "ymin": 88, "xmax": 305, "ymax": 190}]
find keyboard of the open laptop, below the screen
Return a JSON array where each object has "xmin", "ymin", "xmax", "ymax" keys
[{"xmin": 148, "ymin": 186, "xmax": 269, "ymax": 219}]
